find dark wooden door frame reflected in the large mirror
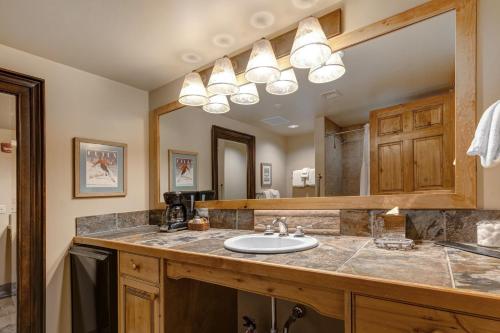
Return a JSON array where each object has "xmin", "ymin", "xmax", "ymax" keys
[{"xmin": 212, "ymin": 125, "xmax": 255, "ymax": 199}]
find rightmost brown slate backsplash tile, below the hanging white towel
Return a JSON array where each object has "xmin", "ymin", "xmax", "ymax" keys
[{"xmin": 446, "ymin": 210, "xmax": 500, "ymax": 243}]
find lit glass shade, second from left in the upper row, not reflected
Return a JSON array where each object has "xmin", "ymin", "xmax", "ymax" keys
[{"xmin": 207, "ymin": 57, "xmax": 238, "ymax": 95}]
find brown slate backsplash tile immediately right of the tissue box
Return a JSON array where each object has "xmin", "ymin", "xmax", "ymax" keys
[{"xmin": 400, "ymin": 210, "xmax": 445, "ymax": 241}]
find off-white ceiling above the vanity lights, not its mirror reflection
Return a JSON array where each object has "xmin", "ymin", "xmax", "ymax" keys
[{"xmin": 0, "ymin": 0, "xmax": 340, "ymax": 90}]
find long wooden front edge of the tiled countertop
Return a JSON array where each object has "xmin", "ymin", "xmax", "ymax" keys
[{"xmin": 73, "ymin": 236, "xmax": 500, "ymax": 320}]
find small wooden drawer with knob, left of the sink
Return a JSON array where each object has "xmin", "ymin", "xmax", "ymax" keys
[{"xmin": 120, "ymin": 252, "xmax": 160, "ymax": 283}]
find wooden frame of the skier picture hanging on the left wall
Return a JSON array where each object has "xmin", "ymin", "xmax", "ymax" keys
[{"xmin": 73, "ymin": 138, "xmax": 128, "ymax": 198}]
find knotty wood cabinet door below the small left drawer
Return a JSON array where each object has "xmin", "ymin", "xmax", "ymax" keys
[{"xmin": 119, "ymin": 277, "xmax": 161, "ymax": 333}]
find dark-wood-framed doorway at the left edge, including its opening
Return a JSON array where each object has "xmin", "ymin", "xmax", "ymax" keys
[{"xmin": 0, "ymin": 69, "xmax": 45, "ymax": 333}]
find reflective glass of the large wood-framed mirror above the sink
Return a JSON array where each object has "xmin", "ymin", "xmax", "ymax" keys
[{"xmin": 160, "ymin": 11, "xmax": 455, "ymax": 199}]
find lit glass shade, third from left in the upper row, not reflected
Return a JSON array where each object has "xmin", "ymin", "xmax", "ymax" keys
[{"xmin": 245, "ymin": 38, "xmax": 280, "ymax": 83}]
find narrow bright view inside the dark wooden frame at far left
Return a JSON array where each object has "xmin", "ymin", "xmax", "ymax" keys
[{"xmin": 0, "ymin": 93, "xmax": 17, "ymax": 332}]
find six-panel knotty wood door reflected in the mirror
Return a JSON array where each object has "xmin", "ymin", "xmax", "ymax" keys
[{"xmin": 370, "ymin": 93, "xmax": 454, "ymax": 194}]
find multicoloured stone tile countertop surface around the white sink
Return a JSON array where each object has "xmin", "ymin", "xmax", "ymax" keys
[{"xmin": 76, "ymin": 226, "xmax": 500, "ymax": 294}]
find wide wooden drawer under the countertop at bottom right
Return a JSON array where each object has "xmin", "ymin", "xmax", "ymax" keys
[{"xmin": 353, "ymin": 296, "xmax": 500, "ymax": 333}]
